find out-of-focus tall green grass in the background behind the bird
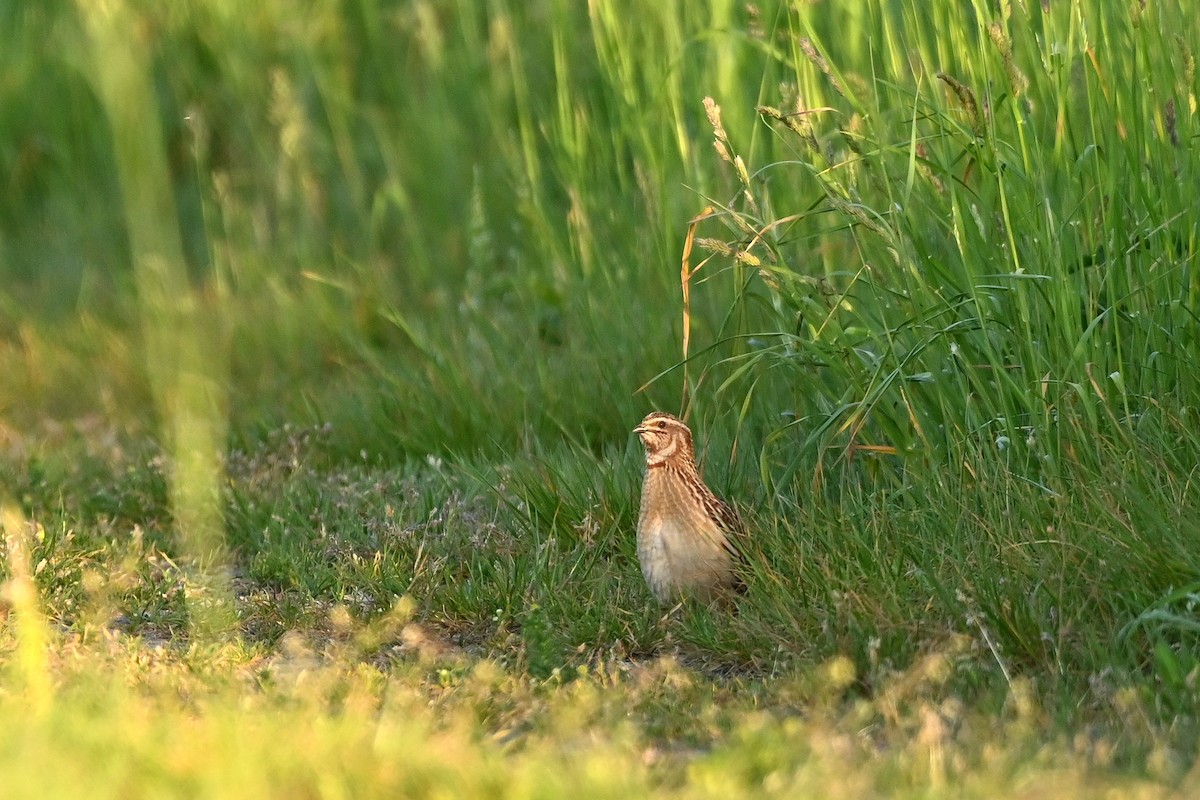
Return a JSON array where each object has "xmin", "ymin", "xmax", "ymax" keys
[{"xmin": 4, "ymin": 2, "xmax": 782, "ymax": 455}]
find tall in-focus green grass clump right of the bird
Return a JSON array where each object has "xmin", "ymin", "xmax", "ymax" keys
[{"xmin": 684, "ymin": 0, "xmax": 1200, "ymax": 728}]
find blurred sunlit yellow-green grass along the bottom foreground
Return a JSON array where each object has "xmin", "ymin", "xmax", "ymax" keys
[{"xmin": 0, "ymin": 614, "xmax": 1178, "ymax": 798}]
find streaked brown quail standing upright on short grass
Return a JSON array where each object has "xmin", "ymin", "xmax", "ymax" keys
[{"xmin": 634, "ymin": 411, "xmax": 742, "ymax": 603}]
